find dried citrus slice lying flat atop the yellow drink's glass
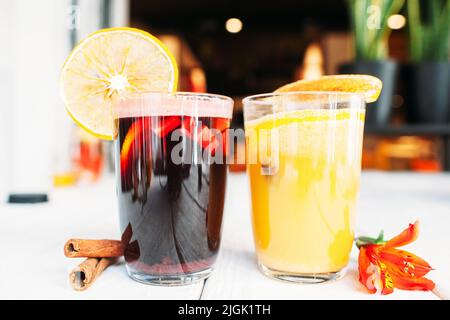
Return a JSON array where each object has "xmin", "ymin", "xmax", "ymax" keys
[{"xmin": 275, "ymin": 74, "xmax": 383, "ymax": 103}]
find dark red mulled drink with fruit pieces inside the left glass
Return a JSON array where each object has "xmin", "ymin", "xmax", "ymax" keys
[{"xmin": 116, "ymin": 116, "xmax": 229, "ymax": 276}]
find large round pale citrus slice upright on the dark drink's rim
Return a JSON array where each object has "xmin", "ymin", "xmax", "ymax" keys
[{"xmin": 60, "ymin": 28, "xmax": 178, "ymax": 140}]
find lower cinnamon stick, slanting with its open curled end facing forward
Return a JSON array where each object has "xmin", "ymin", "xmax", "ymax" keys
[{"xmin": 69, "ymin": 258, "xmax": 117, "ymax": 291}]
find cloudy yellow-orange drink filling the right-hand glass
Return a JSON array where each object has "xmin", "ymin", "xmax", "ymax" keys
[{"xmin": 246, "ymin": 109, "xmax": 364, "ymax": 274}]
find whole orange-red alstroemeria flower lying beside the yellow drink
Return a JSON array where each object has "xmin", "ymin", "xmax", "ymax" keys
[{"xmin": 356, "ymin": 221, "xmax": 435, "ymax": 294}]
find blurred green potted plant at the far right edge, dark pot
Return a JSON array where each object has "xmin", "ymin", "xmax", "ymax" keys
[{"xmin": 404, "ymin": 0, "xmax": 450, "ymax": 123}]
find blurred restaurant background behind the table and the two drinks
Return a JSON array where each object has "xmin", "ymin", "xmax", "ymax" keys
[{"xmin": 0, "ymin": 0, "xmax": 450, "ymax": 200}]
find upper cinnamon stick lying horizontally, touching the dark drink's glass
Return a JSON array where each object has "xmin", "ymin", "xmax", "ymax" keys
[{"xmin": 64, "ymin": 239, "xmax": 123, "ymax": 258}]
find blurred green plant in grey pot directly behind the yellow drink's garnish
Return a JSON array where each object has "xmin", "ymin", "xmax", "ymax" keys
[{"xmin": 340, "ymin": 0, "xmax": 405, "ymax": 125}]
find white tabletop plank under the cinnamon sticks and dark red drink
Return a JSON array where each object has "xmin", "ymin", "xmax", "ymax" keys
[{"xmin": 0, "ymin": 177, "xmax": 203, "ymax": 299}]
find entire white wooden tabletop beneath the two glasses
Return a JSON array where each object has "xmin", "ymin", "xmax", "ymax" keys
[{"xmin": 0, "ymin": 172, "xmax": 450, "ymax": 299}]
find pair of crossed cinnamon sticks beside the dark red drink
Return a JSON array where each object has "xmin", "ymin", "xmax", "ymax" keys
[{"xmin": 64, "ymin": 239, "xmax": 124, "ymax": 291}]
